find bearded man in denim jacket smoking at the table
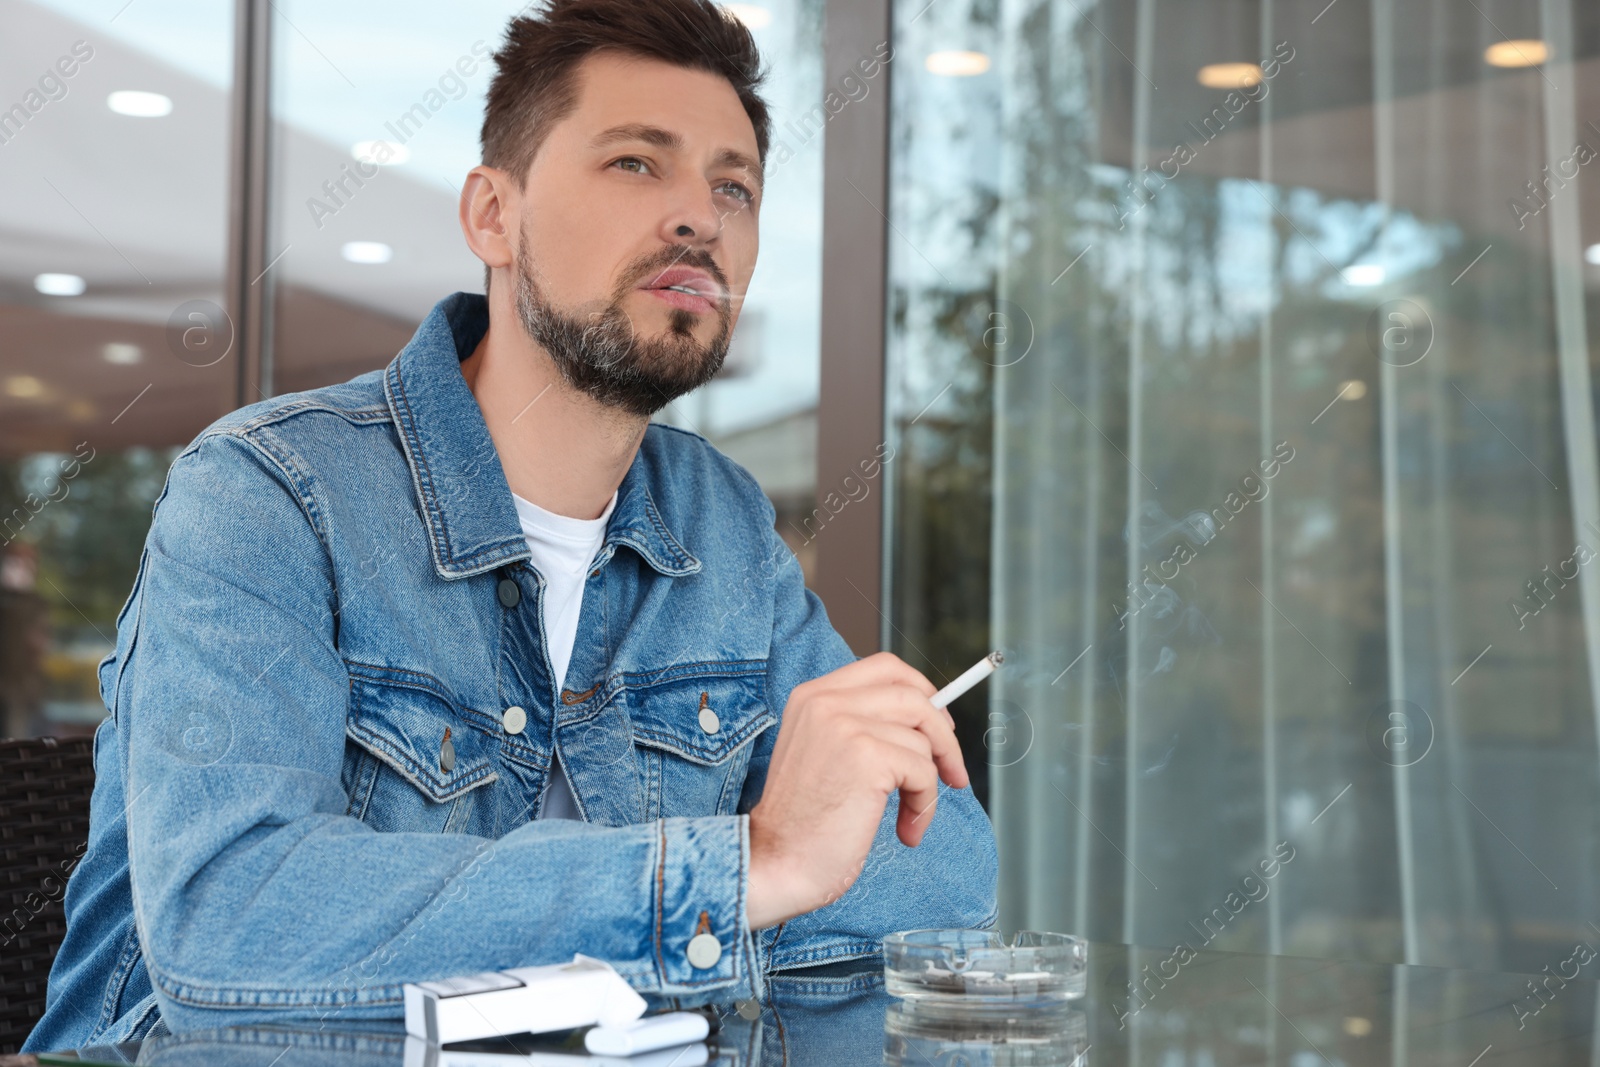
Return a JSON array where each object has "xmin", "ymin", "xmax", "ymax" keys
[{"xmin": 29, "ymin": 0, "xmax": 995, "ymax": 1049}]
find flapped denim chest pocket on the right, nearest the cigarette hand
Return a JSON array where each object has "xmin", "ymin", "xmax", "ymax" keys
[{"xmin": 622, "ymin": 661, "xmax": 778, "ymax": 819}]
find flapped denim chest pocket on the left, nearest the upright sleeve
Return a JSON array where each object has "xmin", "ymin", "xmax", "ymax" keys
[{"xmin": 344, "ymin": 664, "xmax": 499, "ymax": 833}]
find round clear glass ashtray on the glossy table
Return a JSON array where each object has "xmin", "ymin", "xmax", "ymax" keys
[{"xmin": 883, "ymin": 929, "xmax": 1088, "ymax": 1006}]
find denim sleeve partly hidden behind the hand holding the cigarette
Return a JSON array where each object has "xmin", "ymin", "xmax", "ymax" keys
[{"xmin": 739, "ymin": 504, "xmax": 998, "ymax": 971}]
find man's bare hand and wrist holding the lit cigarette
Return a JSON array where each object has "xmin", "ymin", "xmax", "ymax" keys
[{"xmin": 747, "ymin": 653, "xmax": 970, "ymax": 929}]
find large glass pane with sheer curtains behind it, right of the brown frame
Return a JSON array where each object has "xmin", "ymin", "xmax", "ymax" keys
[{"xmin": 888, "ymin": 0, "xmax": 1600, "ymax": 973}]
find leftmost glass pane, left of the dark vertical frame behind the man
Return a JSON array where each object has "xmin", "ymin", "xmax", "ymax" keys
[{"xmin": 0, "ymin": 0, "xmax": 234, "ymax": 736}]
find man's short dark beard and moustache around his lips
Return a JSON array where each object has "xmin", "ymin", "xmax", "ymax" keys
[{"xmin": 517, "ymin": 238, "xmax": 731, "ymax": 418}]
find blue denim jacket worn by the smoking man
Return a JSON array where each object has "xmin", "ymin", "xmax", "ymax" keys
[{"xmin": 26, "ymin": 293, "xmax": 997, "ymax": 1051}]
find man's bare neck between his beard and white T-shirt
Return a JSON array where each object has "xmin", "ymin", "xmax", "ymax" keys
[{"xmin": 461, "ymin": 286, "xmax": 650, "ymax": 518}]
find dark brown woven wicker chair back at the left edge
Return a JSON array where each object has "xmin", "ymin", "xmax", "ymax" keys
[{"xmin": 0, "ymin": 737, "xmax": 94, "ymax": 1054}]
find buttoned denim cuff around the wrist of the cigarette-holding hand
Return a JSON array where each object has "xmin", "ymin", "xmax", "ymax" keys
[{"xmin": 656, "ymin": 816, "xmax": 760, "ymax": 998}]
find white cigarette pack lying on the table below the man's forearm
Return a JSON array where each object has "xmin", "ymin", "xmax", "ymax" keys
[{"xmin": 405, "ymin": 955, "xmax": 645, "ymax": 1045}]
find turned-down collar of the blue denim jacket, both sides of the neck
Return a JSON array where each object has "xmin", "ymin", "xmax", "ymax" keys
[{"xmin": 384, "ymin": 293, "xmax": 701, "ymax": 579}]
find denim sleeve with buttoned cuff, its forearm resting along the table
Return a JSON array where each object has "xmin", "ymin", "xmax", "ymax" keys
[{"xmin": 110, "ymin": 435, "xmax": 763, "ymax": 1032}]
